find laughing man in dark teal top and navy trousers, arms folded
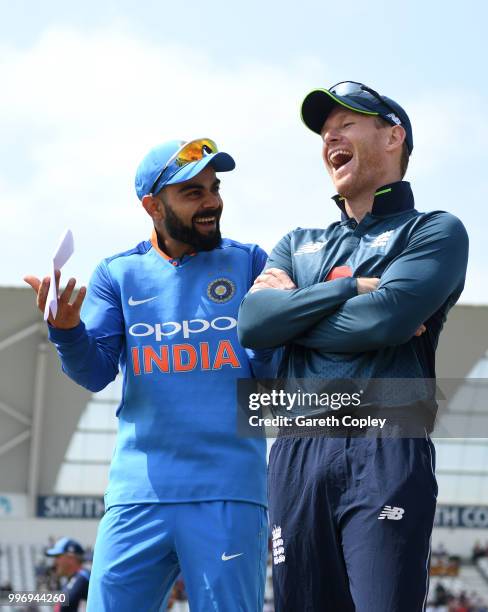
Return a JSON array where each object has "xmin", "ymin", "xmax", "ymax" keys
[{"xmin": 239, "ymin": 81, "xmax": 468, "ymax": 612}]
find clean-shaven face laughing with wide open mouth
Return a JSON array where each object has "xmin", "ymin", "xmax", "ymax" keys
[{"xmin": 321, "ymin": 106, "xmax": 392, "ymax": 199}]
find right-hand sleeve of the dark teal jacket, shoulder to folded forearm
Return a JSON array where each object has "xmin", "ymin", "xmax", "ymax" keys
[{"xmin": 295, "ymin": 212, "xmax": 468, "ymax": 353}]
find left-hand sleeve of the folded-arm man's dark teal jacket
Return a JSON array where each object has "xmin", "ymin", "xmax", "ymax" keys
[{"xmin": 237, "ymin": 234, "xmax": 357, "ymax": 349}]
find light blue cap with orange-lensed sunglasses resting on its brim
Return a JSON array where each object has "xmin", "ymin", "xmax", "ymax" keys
[{"xmin": 135, "ymin": 138, "xmax": 236, "ymax": 200}]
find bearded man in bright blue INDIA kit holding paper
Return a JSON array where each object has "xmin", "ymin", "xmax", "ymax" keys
[{"xmin": 26, "ymin": 139, "xmax": 273, "ymax": 612}]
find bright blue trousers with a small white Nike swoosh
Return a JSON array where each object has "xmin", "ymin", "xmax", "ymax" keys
[{"xmin": 87, "ymin": 501, "xmax": 268, "ymax": 612}]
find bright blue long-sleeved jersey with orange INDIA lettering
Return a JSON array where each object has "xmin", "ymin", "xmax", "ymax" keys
[{"xmin": 49, "ymin": 235, "xmax": 277, "ymax": 507}]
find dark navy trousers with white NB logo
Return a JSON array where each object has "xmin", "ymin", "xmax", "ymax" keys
[{"xmin": 269, "ymin": 437, "xmax": 437, "ymax": 612}]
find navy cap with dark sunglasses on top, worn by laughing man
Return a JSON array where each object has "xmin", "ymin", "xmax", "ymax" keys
[{"xmin": 301, "ymin": 81, "xmax": 413, "ymax": 153}]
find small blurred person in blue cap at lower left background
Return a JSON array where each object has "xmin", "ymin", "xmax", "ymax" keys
[{"xmin": 45, "ymin": 538, "xmax": 90, "ymax": 612}]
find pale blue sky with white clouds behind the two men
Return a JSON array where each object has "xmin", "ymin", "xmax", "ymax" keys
[{"xmin": 0, "ymin": 0, "xmax": 488, "ymax": 304}]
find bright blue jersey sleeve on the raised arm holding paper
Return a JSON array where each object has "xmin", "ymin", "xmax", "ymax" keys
[{"xmin": 49, "ymin": 262, "xmax": 124, "ymax": 392}]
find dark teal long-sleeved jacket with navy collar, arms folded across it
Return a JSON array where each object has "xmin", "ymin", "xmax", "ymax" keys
[{"xmin": 238, "ymin": 181, "xmax": 468, "ymax": 388}]
